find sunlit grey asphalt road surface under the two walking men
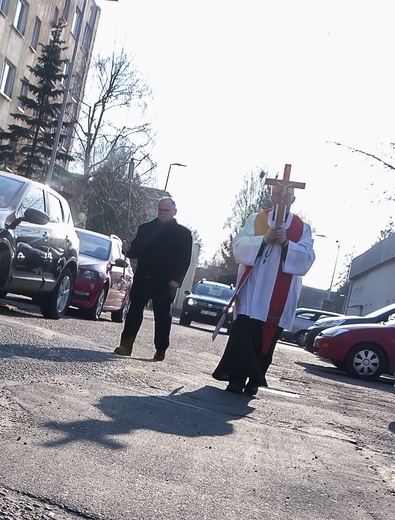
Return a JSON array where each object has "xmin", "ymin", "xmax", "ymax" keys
[{"xmin": 0, "ymin": 299, "xmax": 395, "ymax": 520}]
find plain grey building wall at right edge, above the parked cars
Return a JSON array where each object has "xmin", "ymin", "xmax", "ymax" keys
[{"xmin": 345, "ymin": 233, "xmax": 395, "ymax": 316}]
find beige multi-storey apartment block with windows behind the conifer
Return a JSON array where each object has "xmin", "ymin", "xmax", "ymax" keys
[{"xmin": 0, "ymin": 0, "xmax": 100, "ymax": 173}]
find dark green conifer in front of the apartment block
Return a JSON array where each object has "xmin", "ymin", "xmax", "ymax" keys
[{"xmin": 0, "ymin": 20, "xmax": 73, "ymax": 181}]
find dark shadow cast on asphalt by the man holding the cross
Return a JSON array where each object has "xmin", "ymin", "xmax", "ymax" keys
[{"xmin": 43, "ymin": 386, "xmax": 254, "ymax": 449}]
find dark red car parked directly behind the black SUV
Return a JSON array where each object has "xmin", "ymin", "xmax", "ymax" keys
[{"xmin": 70, "ymin": 228, "xmax": 133, "ymax": 323}]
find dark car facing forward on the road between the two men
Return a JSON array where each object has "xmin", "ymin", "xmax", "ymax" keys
[{"xmin": 180, "ymin": 279, "xmax": 235, "ymax": 333}]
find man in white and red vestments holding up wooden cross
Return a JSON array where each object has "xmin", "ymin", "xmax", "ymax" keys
[{"xmin": 213, "ymin": 164, "xmax": 315, "ymax": 395}]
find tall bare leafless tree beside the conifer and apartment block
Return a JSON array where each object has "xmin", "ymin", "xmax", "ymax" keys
[{"xmin": 74, "ymin": 49, "xmax": 152, "ymax": 180}]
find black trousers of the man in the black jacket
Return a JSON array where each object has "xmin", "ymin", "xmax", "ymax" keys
[{"xmin": 121, "ymin": 297, "xmax": 172, "ymax": 351}]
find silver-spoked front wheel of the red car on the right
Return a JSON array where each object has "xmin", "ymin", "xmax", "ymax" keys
[{"xmin": 345, "ymin": 343, "xmax": 387, "ymax": 381}]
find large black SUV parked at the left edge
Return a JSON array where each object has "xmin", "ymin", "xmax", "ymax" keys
[{"xmin": 0, "ymin": 171, "xmax": 79, "ymax": 319}]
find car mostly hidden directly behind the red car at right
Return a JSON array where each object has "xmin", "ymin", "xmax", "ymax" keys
[{"xmin": 304, "ymin": 303, "xmax": 395, "ymax": 353}]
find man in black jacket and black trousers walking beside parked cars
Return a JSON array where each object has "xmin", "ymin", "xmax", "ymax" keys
[{"xmin": 114, "ymin": 197, "xmax": 192, "ymax": 361}]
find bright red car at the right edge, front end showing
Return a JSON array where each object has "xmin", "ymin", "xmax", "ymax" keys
[{"xmin": 315, "ymin": 320, "xmax": 395, "ymax": 381}]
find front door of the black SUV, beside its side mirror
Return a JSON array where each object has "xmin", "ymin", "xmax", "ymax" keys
[{"xmin": 8, "ymin": 186, "xmax": 48, "ymax": 292}]
